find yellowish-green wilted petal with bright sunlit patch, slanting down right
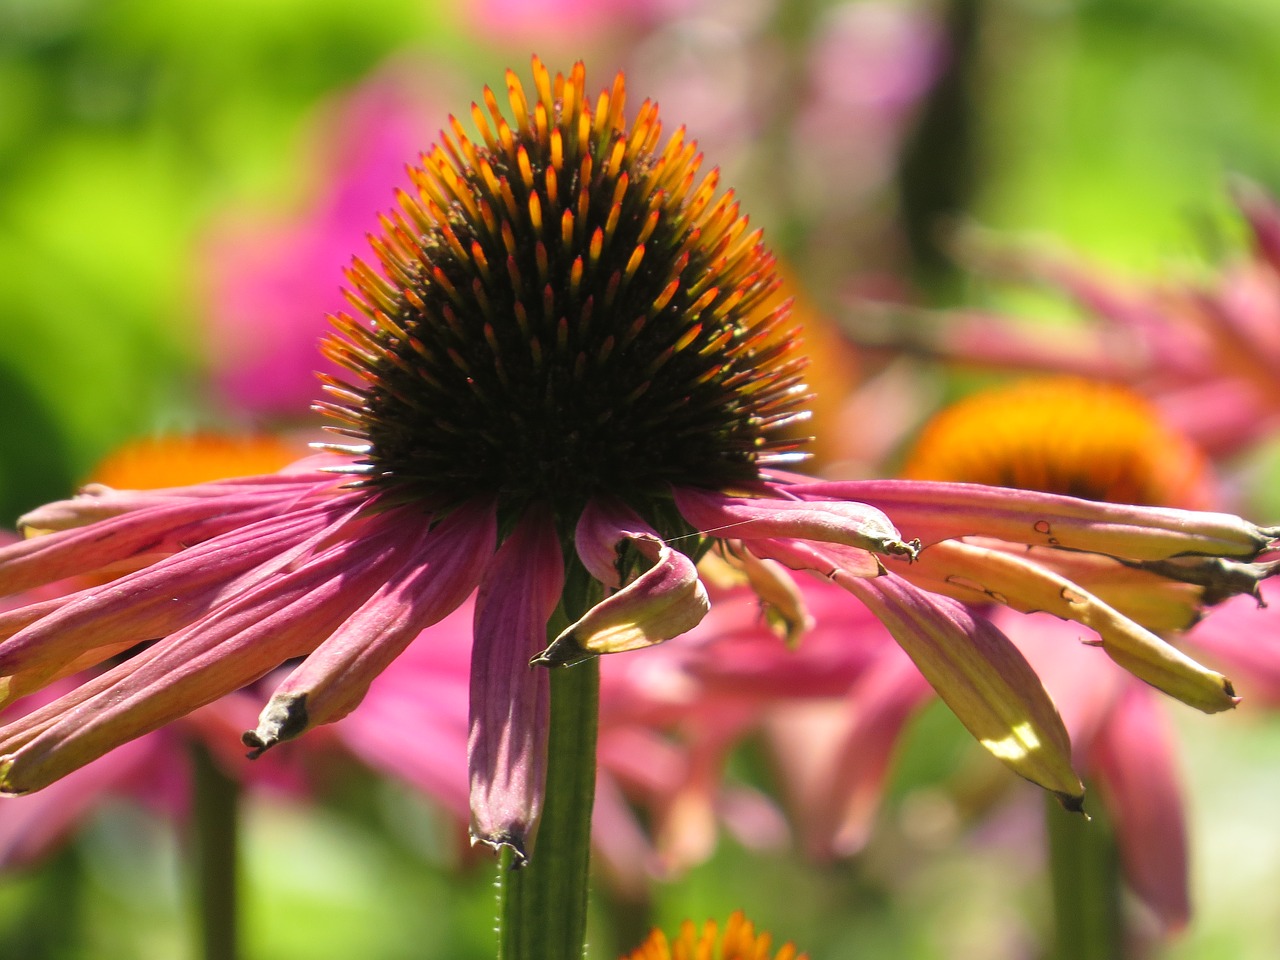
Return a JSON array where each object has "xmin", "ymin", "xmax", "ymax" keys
[{"xmin": 844, "ymin": 573, "xmax": 1084, "ymax": 810}]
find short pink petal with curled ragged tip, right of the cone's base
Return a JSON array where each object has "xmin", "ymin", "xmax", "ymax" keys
[{"xmin": 675, "ymin": 486, "xmax": 919, "ymax": 558}]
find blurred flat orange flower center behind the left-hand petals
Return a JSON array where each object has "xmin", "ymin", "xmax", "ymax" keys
[{"xmin": 90, "ymin": 434, "xmax": 307, "ymax": 490}]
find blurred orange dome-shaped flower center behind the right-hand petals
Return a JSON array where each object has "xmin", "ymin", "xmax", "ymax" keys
[{"xmin": 902, "ymin": 376, "xmax": 1213, "ymax": 509}]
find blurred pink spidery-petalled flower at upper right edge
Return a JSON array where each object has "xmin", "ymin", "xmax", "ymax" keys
[{"xmin": 890, "ymin": 182, "xmax": 1280, "ymax": 458}]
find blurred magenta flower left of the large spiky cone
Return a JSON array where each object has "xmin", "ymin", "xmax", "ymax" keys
[{"xmin": 197, "ymin": 70, "xmax": 444, "ymax": 417}]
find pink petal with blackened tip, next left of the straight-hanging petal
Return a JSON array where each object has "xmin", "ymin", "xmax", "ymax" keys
[{"xmin": 246, "ymin": 502, "xmax": 497, "ymax": 751}]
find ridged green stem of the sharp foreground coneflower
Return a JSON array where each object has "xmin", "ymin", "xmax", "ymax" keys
[{"xmin": 498, "ymin": 632, "xmax": 600, "ymax": 960}]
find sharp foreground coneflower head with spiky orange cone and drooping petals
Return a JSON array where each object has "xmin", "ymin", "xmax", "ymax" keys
[{"xmin": 0, "ymin": 59, "xmax": 1277, "ymax": 870}]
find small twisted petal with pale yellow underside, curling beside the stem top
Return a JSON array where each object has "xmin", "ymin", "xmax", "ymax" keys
[{"xmin": 532, "ymin": 535, "xmax": 710, "ymax": 667}]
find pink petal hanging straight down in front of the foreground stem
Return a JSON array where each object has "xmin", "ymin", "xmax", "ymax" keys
[{"xmin": 467, "ymin": 508, "xmax": 564, "ymax": 859}]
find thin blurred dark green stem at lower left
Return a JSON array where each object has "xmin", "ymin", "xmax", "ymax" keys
[{"xmin": 191, "ymin": 744, "xmax": 239, "ymax": 960}]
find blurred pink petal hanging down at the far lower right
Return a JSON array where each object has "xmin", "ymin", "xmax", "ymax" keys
[{"xmin": 1088, "ymin": 684, "xmax": 1190, "ymax": 933}]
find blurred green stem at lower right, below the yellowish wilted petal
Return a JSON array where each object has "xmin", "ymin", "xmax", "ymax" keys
[{"xmin": 1044, "ymin": 797, "xmax": 1126, "ymax": 960}]
